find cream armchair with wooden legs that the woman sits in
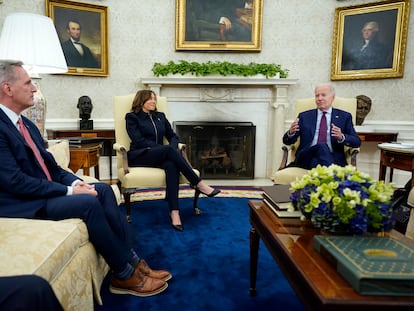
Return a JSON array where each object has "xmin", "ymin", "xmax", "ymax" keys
[{"xmin": 113, "ymin": 94, "xmax": 201, "ymax": 222}]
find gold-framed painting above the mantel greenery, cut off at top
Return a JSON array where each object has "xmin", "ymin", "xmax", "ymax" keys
[{"xmin": 175, "ymin": 0, "xmax": 263, "ymax": 52}]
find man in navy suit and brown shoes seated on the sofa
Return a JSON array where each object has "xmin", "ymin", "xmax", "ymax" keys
[{"xmin": 0, "ymin": 60, "xmax": 171, "ymax": 297}]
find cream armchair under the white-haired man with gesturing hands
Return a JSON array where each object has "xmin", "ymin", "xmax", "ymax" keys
[{"xmin": 272, "ymin": 97, "xmax": 359, "ymax": 185}]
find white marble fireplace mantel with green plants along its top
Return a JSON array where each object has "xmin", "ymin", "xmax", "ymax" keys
[{"xmin": 141, "ymin": 76, "xmax": 298, "ymax": 178}]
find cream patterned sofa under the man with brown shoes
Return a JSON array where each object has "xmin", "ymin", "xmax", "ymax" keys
[{"xmin": 0, "ymin": 141, "xmax": 120, "ymax": 311}]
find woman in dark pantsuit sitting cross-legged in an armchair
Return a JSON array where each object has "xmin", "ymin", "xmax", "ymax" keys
[{"xmin": 125, "ymin": 90, "xmax": 220, "ymax": 231}]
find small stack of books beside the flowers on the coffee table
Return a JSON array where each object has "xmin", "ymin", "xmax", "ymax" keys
[{"xmin": 262, "ymin": 185, "xmax": 302, "ymax": 218}]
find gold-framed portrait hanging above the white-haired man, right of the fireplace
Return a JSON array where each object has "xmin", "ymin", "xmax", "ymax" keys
[{"xmin": 331, "ymin": 0, "xmax": 410, "ymax": 80}]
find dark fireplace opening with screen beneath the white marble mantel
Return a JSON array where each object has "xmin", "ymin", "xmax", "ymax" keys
[{"xmin": 173, "ymin": 121, "xmax": 256, "ymax": 179}]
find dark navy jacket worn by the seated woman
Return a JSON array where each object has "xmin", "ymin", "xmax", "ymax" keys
[{"xmin": 125, "ymin": 110, "xmax": 178, "ymax": 158}]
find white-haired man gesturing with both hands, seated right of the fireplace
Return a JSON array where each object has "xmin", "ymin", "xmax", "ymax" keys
[{"xmin": 283, "ymin": 84, "xmax": 361, "ymax": 169}]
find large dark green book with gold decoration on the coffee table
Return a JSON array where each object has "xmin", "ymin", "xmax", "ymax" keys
[{"xmin": 314, "ymin": 235, "xmax": 414, "ymax": 296}]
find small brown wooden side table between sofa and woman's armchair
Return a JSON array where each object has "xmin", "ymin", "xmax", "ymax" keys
[{"xmin": 69, "ymin": 143, "xmax": 102, "ymax": 179}]
